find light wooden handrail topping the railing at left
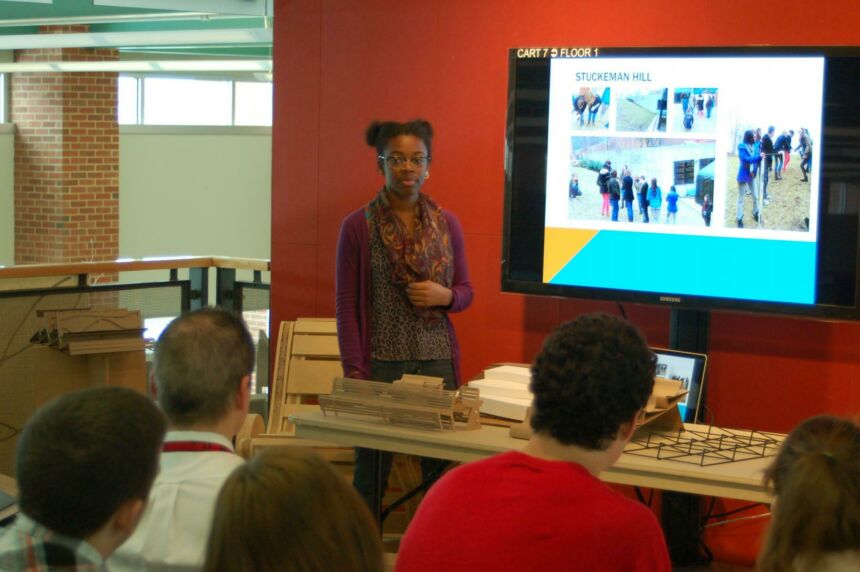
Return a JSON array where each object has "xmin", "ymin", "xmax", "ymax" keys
[{"xmin": 0, "ymin": 256, "xmax": 270, "ymax": 280}]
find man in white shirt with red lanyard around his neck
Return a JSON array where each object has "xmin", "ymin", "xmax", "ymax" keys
[{"xmin": 108, "ymin": 308, "xmax": 254, "ymax": 572}]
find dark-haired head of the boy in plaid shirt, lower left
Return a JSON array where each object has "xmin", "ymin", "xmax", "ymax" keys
[{"xmin": 15, "ymin": 387, "xmax": 165, "ymax": 556}]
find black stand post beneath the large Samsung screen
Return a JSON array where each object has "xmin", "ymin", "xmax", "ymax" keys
[{"xmin": 661, "ymin": 309, "xmax": 711, "ymax": 565}]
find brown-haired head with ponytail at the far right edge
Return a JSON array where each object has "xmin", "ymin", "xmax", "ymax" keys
[{"xmin": 758, "ymin": 415, "xmax": 860, "ymax": 572}]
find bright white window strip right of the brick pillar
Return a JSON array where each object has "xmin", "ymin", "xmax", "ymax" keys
[{"xmin": 117, "ymin": 76, "xmax": 272, "ymax": 126}]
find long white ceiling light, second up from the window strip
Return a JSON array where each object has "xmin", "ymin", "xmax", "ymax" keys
[{"xmin": 0, "ymin": 28, "xmax": 272, "ymax": 50}]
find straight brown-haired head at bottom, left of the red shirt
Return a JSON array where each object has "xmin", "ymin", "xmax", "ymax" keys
[{"xmin": 203, "ymin": 448, "xmax": 382, "ymax": 572}]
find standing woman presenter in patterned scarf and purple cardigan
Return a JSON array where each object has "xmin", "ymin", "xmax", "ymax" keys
[{"xmin": 336, "ymin": 119, "xmax": 472, "ymax": 510}]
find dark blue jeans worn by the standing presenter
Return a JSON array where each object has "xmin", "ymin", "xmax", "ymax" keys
[{"xmin": 352, "ymin": 359, "xmax": 457, "ymax": 514}]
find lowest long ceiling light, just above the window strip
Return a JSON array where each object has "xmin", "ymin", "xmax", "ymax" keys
[{"xmin": 0, "ymin": 59, "xmax": 272, "ymax": 73}]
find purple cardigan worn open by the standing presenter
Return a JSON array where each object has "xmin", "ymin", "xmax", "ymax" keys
[{"xmin": 335, "ymin": 207, "xmax": 472, "ymax": 385}]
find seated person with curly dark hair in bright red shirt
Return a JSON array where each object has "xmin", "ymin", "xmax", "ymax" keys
[{"xmin": 397, "ymin": 314, "xmax": 671, "ymax": 572}]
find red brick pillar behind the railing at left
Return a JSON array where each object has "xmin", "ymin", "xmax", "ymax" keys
[{"xmin": 10, "ymin": 26, "xmax": 119, "ymax": 266}]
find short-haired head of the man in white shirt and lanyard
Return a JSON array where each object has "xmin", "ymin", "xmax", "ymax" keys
[{"xmin": 153, "ymin": 308, "xmax": 255, "ymax": 434}]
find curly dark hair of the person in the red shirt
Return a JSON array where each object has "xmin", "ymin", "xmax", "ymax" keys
[{"xmin": 531, "ymin": 314, "xmax": 657, "ymax": 450}]
